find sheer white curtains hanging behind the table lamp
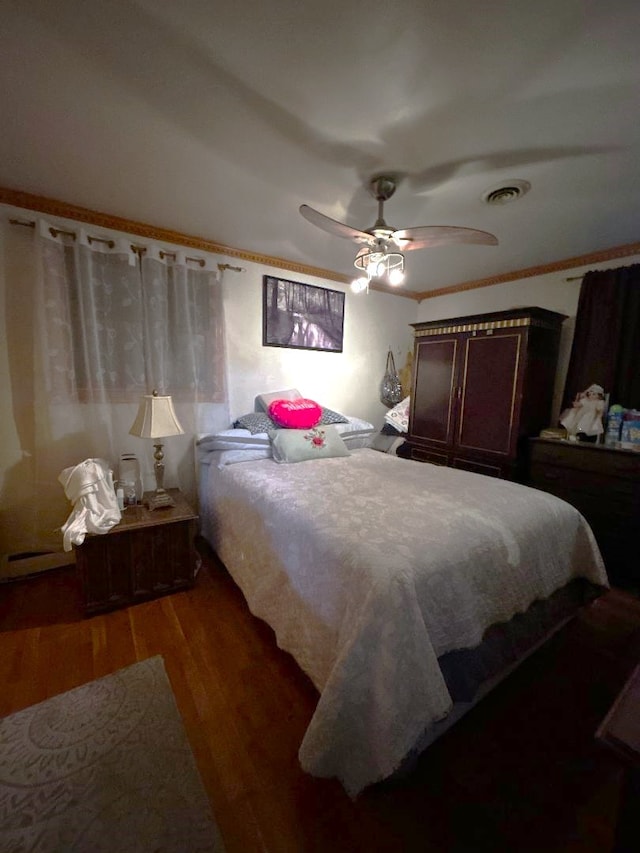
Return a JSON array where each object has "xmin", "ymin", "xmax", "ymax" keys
[{"xmin": 33, "ymin": 220, "xmax": 229, "ymax": 549}]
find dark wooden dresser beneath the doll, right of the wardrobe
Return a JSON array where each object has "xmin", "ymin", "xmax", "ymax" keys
[{"xmin": 528, "ymin": 438, "xmax": 640, "ymax": 586}]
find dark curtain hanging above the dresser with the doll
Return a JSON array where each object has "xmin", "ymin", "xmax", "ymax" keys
[{"xmin": 562, "ymin": 264, "xmax": 640, "ymax": 409}]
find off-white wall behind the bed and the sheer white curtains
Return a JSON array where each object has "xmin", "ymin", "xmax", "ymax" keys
[{"xmin": 0, "ymin": 206, "xmax": 416, "ymax": 559}]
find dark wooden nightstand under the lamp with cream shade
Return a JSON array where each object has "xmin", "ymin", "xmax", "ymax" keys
[{"xmin": 75, "ymin": 489, "xmax": 198, "ymax": 616}]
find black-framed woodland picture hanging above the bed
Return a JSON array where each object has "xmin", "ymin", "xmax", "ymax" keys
[{"xmin": 262, "ymin": 275, "xmax": 344, "ymax": 352}]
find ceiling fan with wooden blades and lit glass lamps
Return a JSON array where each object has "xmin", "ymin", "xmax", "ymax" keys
[{"xmin": 300, "ymin": 175, "xmax": 498, "ymax": 292}]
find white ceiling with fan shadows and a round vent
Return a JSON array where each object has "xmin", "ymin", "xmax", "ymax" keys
[{"xmin": 0, "ymin": 0, "xmax": 640, "ymax": 291}]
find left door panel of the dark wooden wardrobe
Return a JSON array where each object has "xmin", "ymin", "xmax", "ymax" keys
[{"xmin": 409, "ymin": 335, "xmax": 460, "ymax": 449}]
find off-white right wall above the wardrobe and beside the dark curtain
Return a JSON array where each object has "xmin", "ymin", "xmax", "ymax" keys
[{"xmin": 416, "ymin": 255, "xmax": 640, "ymax": 424}]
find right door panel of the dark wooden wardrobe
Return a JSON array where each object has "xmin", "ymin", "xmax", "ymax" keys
[{"xmin": 456, "ymin": 331, "xmax": 524, "ymax": 457}]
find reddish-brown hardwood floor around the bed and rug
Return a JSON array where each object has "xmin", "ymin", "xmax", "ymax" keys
[{"xmin": 0, "ymin": 547, "xmax": 640, "ymax": 853}]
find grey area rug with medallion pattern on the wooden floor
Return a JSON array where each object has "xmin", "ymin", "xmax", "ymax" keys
[{"xmin": 0, "ymin": 656, "xmax": 224, "ymax": 853}]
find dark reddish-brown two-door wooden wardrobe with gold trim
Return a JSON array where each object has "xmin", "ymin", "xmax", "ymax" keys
[{"xmin": 403, "ymin": 308, "xmax": 566, "ymax": 480}]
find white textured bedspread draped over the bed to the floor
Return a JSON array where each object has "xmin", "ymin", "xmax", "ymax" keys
[{"xmin": 202, "ymin": 449, "xmax": 607, "ymax": 795}]
